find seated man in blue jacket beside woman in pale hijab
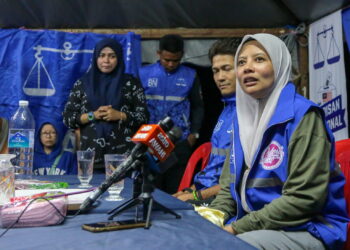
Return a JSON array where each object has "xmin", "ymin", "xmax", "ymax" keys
[{"xmin": 174, "ymin": 39, "xmax": 238, "ymax": 205}]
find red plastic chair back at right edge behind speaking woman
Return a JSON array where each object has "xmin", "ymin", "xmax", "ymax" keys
[{"xmin": 335, "ymin": 139, "xmax": 350, "ymax": 249}]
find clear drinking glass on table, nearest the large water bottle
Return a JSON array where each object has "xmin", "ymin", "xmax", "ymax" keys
[{"xmin": 77, "ymin": 151, "xmax": 95, "ymax": 188}]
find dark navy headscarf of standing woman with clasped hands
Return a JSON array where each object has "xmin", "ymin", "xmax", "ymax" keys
[{"xmin": 81, "ymin": 38, "xmax": 125, "ymax": 138}]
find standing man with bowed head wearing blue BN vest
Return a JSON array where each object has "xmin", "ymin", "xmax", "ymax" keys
[{"xmin": 140, "ymin": 35, "xmax": 204, "ymax": 193}]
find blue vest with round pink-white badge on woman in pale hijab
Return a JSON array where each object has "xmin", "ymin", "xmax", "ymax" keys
[{"xmin": 228, "ymin": 83, "xmax": 349, "ymax": 249}]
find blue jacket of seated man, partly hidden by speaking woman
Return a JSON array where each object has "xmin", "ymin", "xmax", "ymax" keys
[{"xmin": 194, "ymin": 95, "xmax": 236, "ymax": 190}]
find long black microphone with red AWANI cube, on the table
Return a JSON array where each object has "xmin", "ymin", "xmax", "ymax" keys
[{"xmin": 79, "ymin": 117, "xmax": 182, "ymax": 212}]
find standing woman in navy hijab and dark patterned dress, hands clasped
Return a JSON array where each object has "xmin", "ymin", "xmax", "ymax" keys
[{"xmin": 63, "ymin": 38, "xmax": 148, "ymax": 172}]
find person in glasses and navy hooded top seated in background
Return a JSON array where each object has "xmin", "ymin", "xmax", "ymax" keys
[{"xmin": 33, "ymin": 120, "xmax": 77, "ymax": 175}]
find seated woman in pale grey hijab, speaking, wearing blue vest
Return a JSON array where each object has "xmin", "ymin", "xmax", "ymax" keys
[{"xmin": 211, "ymin": 34, "xmax": 349, "ymax": 249}]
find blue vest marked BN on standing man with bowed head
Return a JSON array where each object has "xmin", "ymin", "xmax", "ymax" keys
[{"xmin": 139, "ymin": 62, "xmax": 196, "ymax": 139}]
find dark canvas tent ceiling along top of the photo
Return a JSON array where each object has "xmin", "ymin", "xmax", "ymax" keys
[{"xmin": 0, "ymin": 0, "xmax": 350, "ymax": 29}]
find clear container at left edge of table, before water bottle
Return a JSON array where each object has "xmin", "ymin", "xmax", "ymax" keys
[{"xmin": 0, "ymin": 154, "xmax": 16, "ymax": 205}]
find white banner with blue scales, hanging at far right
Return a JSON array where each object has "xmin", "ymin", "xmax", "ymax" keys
[{"xmin": 309, "ymin": 10, "xmax": 348, "ymax": 141}]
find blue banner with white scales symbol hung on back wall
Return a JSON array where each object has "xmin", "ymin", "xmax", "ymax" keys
[{"xmin": 0, "ymin": 29, "xmax": 141, "ymax": 127}]
